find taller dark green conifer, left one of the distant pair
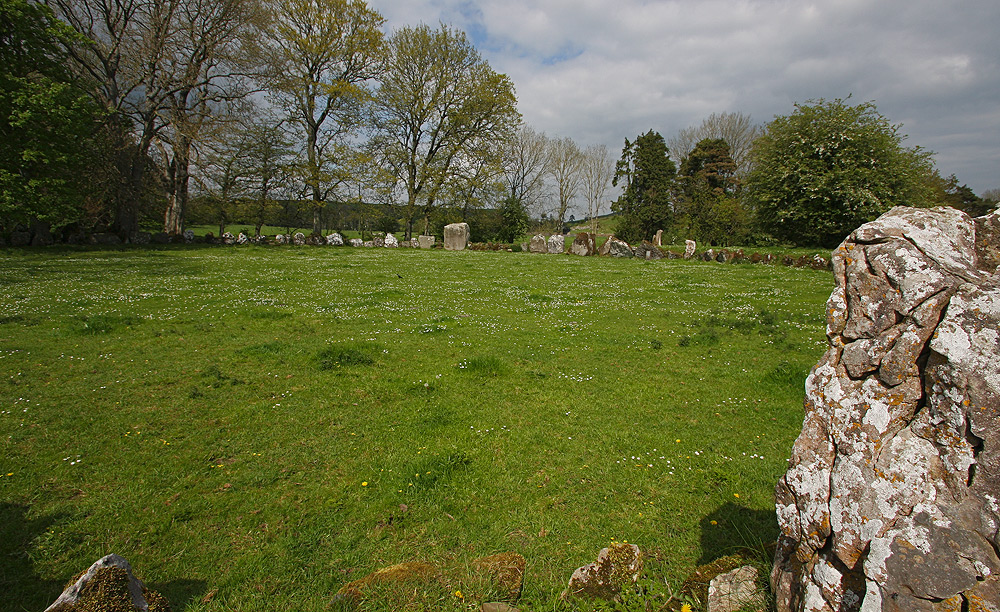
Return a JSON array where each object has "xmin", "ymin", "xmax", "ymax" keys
[{"xmin": 611, "ymin": 130, "xmax": 677, "ymax": 242}]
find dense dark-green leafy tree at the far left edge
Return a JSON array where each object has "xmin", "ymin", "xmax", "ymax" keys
[{"xmin": 0, "ymin": 0, "xmax": 99, "ymax": 231}]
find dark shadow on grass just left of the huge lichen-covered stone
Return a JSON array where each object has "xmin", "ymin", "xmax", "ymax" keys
[{"xmin": 698, "ymin": 502, "xmax": 778, "ymax": 565}]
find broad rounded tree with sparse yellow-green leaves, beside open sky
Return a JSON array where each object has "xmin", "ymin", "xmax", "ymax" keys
[{"xmin": 375, "ymin": 25, "xmax": 520, "ymax": 238}]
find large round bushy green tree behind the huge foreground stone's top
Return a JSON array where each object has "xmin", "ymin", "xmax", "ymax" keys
[{"xmin": 747, "ymin": 99, "xmax": 931, "ymax": 247}]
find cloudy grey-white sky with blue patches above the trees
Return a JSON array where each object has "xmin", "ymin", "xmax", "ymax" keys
[{"xmin": 369, "ymin": 0, "xmax": 1000, "ymax": 193}]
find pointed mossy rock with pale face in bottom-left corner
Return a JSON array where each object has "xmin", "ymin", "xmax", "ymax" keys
[{"xmin": 45, "ymin": 555, "xmax": 170, "ymax": 612}]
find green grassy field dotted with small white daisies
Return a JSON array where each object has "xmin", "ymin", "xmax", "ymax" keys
[{"xmin": 0, "ymin": 245, "xmax": 832, "ymax": 611}]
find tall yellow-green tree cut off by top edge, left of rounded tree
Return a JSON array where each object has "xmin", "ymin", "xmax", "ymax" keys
[{"xmin": 263, "ymin": 0, "xmax": 386, "ymax": 233}]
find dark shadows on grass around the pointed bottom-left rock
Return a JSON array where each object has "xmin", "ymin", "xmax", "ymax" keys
[{"xmin": 0, "ymin": 502, "xmax": 206, "ymax": 612}]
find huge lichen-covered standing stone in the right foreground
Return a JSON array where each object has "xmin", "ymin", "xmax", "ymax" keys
[{"xmin": 771, "ymin": 208, "xmax": 1000, "ymax": 612}]
